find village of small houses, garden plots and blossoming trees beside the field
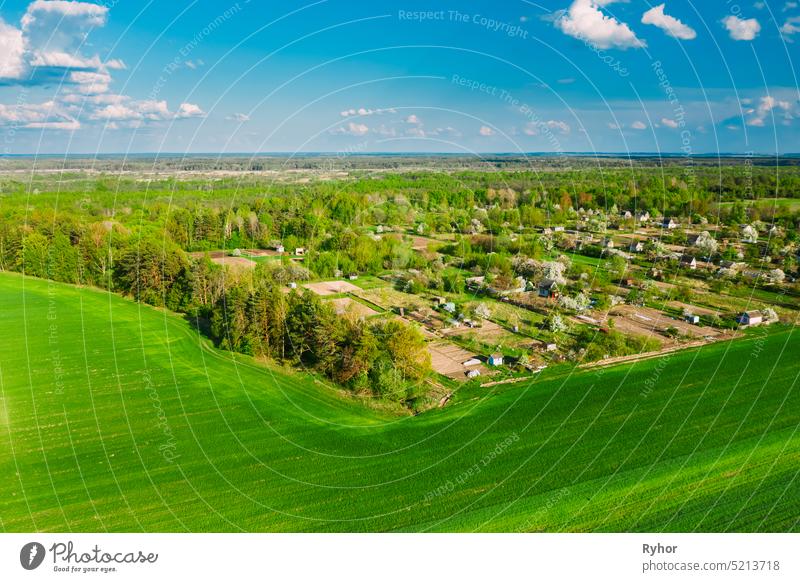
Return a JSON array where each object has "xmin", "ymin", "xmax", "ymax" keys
[{"xmin": 202, "ymin": 203, "xmax": 797, "ymax": 394}]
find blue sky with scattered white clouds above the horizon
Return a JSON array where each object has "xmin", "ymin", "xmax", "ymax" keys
[{"xmin": 0, "ymin": 0, "xmax": 800, "ymax": 155}]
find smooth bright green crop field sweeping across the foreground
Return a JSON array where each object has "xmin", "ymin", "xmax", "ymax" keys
[{"xmin": 0, "ymin": 274, "xmax": 800, "ymax": 532}]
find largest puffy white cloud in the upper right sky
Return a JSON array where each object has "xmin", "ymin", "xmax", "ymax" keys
[{"xmin": 555, "ymin": 0, "xmax": 647, "ymax": 49}]
